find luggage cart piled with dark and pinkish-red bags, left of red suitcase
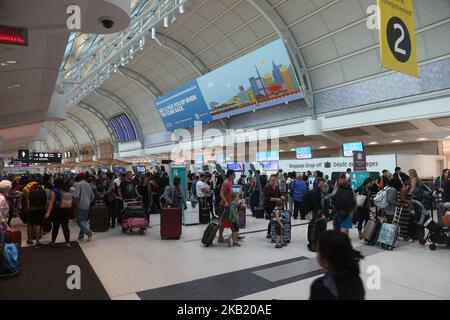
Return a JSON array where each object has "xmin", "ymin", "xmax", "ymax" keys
[{"xmin": 122, "ymin": 199, "xmax": 149, "ymax": 235}]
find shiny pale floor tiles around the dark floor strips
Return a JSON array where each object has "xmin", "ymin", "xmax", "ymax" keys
[{"xmin": 10, "ymin": 216, "xmax": 450, "ymax": 300}]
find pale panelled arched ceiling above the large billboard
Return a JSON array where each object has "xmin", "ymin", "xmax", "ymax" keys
[{"xmin": 31, "ymin": 0, "xmax": 450, "ymax": 154}]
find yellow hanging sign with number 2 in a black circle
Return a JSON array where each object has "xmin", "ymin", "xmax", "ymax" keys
[{"xmin": 378, "ymin": 0, "xmax": 419, "ymax": 77}]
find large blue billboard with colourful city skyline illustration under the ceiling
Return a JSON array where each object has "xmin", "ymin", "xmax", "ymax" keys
[{"xmin": 155, "ymin": 39, "xmax": 303, "ymax": 131}]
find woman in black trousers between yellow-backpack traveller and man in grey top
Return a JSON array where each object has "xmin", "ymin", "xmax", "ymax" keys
[{"xmin": 45, "ymin": 178, "xmax": 70, "ymax": 248}]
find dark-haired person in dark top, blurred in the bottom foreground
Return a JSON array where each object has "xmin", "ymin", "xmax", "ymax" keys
[{"xmin": 309, "ymin": 230, "xmax": 365, "ymax": 300}]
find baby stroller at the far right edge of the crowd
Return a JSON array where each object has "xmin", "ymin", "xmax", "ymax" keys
[{"xmin": 412, "ymin": 200, "xmax": 450, "ymax": 251}]
